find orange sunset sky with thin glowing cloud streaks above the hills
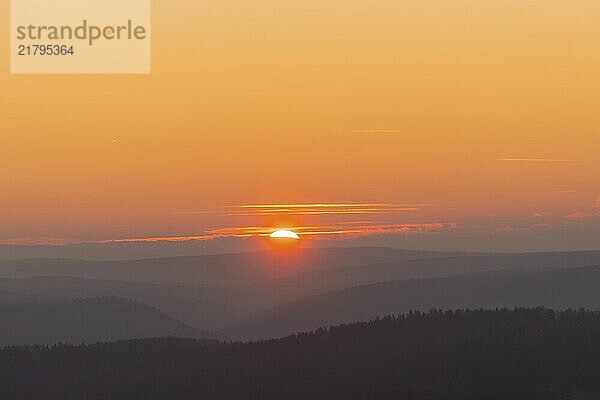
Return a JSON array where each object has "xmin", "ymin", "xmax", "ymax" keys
[{"xmin": 0, "ymin": 0, "xmax": 600, "ymax": 247}]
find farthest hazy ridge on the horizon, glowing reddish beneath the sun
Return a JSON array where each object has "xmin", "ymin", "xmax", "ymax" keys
[{"xmin": 0, "ymin": 247, "xmax": 446, "ymax": 288}]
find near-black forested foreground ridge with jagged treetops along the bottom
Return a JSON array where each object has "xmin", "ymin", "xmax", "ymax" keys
[{"xmin": 0, "ymin": 309, "xmax": 600, "ymax": 400}]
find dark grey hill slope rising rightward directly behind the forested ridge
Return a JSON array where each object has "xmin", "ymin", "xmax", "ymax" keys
[{"xmin": 220, "ymin": 267, "xmax": 600, "ymax": 339}]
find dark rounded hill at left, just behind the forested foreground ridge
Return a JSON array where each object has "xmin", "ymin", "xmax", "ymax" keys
[{"xmin": 0, "ymin": 297, "xmax": 202, "ymax": 346}]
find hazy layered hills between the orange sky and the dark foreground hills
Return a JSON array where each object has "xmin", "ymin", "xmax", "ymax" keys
[{"xmin": 0, "ymin": 247, "xmax": 600, "ymax": 340}]
